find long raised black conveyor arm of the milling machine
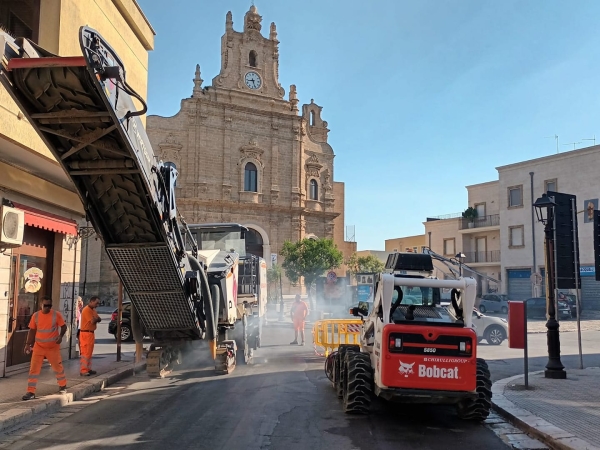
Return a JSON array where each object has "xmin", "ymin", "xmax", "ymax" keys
[{"xmin": 0, "ymin": 27, "xmax": 244, "ymax": 376}]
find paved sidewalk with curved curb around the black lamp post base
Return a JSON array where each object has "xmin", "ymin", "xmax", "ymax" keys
[{"xmin": 492, "ymin": 367, "xmax": 600, "ymax": 450}]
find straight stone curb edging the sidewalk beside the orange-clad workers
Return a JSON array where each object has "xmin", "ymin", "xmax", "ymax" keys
[{"xmin": 0, "ymin": 362, "xmax": 146, "ymax": 432}]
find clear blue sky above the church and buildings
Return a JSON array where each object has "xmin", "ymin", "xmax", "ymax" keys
[{"xmin": 138, "ymin": 0, "xmax": 600, "ymax": 250}]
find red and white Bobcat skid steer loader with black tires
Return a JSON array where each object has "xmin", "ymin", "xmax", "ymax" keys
[{"xmin": 325, "ymin": 253, "xmax": 492, "ymax": 420}]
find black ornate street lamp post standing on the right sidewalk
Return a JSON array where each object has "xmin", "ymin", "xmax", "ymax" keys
[{"xmin": 533, "ymin": 194, "xmax": 567, "ymax": 379}]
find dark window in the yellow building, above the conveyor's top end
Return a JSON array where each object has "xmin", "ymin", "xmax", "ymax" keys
[{"xmin": 0, "ymin": 0, "xmax": 40, "ymax": 43}]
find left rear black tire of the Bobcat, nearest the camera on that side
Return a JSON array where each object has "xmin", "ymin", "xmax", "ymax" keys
[{"xmin": 344, "ymin": 352, "xmax": 373, "ymax": 415}]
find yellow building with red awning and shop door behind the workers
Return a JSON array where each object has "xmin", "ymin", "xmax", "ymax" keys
[{"xmin": 0, "ymin": 0, "xmax": 154, "ymax": 376}]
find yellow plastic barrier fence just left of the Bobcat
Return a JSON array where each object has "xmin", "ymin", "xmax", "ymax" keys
[{"xmin": 313, "ymin": 319, "xmax": 362, "ymax": 356}]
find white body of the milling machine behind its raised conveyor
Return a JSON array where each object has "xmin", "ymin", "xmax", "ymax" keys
[{"xmin": 187, "ymin": 223, "xmax": 267, "ymax": 371}]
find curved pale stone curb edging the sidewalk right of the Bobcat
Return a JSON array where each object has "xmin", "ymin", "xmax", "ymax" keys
[{"xmin": 492, "ymin": 370, "xmax": 600, "ymax": 450}]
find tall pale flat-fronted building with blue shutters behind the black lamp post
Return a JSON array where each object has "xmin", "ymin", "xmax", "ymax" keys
[{"xmin": 497, "ymin": 145, "xmax": 600, "ymax": 309}]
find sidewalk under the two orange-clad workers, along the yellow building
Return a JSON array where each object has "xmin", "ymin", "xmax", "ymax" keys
[{"xmin": 0, "ymin": 353, "xmax": 146, "ymax": 431}]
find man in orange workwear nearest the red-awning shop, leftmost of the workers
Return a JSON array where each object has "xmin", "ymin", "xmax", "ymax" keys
[{"xmin": 23, "ymin": 295, "xmax": 67, "ymax": 400}]
